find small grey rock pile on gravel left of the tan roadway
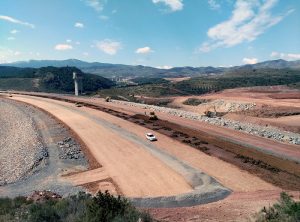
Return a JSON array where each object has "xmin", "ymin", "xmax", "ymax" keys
[{"xmin": 57, "ymin": 137, "xmax": 84, "ymax": 159}]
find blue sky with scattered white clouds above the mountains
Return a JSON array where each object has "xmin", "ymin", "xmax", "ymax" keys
[{"xmin": 0, "ymin": 0, "xmax": 300, "ymax": 68}]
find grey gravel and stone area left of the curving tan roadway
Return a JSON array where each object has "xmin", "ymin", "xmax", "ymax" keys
[{"xmin": 0, "ymin": 97, "xmax": 88, "ymax": 197}]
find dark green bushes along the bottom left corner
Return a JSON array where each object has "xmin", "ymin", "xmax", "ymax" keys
[{"xmin": 0, "ymin": 191, "xmax": 153, "ymax": 222}]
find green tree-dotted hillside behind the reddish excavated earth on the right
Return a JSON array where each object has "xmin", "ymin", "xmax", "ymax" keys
[{"xmin": 99, "ymin": 66, "xmax": 300, "ymax": 99}]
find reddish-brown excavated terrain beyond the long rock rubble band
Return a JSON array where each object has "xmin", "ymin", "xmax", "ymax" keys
[{"xmin": 168, "ymin": 86, "xmax": 300, "ymax": 133}]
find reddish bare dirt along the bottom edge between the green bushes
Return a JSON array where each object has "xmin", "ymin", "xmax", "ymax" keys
[{"xmin": 148, "ymin": 191, "xmax": 300, "ymax": 222}]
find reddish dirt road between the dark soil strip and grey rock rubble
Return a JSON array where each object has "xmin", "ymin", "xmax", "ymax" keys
[{"xmin": 64, "ymin": 96, "xmax": 300, "ymax": 162}]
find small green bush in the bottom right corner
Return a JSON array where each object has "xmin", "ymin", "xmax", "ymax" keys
[{"xmin": 256, "ymin": 192, "xmax": 300, "ymax": 222}]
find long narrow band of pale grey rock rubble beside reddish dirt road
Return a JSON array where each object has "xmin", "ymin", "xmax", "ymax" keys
[{"xmin": 112, "ymin": 100, "xmax": 300, "ymax": 145}]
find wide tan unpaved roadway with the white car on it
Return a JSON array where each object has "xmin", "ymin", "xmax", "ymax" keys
[{"xmin": 13, "ymin": 96, "xmax": 277, "ymax": 196}]
